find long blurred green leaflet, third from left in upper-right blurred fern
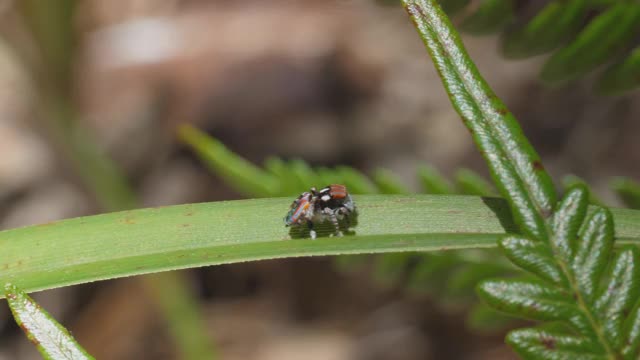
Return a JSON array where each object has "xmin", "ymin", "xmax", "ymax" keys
[{"xmin": 540, "ymin": 1, "xmax": 640, "ymax": 83}]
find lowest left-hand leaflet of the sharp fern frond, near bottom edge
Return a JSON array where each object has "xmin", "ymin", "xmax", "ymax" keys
[{"xmin": 507, "ymin": 328, "xmax": 607, "ymax": 360}]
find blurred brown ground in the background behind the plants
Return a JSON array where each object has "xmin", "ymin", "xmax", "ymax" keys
[{"xmin": 0, "ymin": 0, "xmax": 640, "ymax": 360}]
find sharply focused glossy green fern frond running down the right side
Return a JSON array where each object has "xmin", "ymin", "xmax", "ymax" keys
[{"xmin": 403, "ymin": 0, "xmax": 640, "ymax": 359}]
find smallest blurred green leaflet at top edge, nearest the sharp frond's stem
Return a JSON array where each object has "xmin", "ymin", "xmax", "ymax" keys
[{"xmin": 460, "ymin": 0, "xmax": 514, "ymax": 35}]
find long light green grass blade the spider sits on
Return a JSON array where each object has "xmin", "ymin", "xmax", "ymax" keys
[{"xmin": 0, "ymin": 195, "xmax": 640, "ymax": 292}]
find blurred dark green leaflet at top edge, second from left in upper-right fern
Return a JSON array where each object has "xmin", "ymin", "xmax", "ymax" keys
[{"xmin": 502, "ymin": 0, "xmax": 590, "ymax": 58}]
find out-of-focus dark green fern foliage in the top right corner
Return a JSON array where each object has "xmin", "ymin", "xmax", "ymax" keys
[{"xmin": 378, "ymin": 0, "xmax": 640, "ymax": 95}]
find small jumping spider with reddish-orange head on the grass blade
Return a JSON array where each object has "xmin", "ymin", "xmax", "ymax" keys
[{"xmin": 284, "ymin": 184, "xmax": 357, "ymax": 239}]
